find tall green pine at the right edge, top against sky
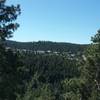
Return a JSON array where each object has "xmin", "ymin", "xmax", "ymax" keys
[{"xmin": 84, "ymin": 30, "xmax": 100, "ymax": 100}]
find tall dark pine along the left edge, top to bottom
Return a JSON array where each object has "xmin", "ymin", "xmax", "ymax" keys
[{"xmin": 0, "ymin": 0, "xmax": 20, "ymax": 100}]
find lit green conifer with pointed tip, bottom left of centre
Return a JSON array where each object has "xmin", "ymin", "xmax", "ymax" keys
[{"xmin": 18, "ymin": 73, "xmax": 54, "ymax": 100}]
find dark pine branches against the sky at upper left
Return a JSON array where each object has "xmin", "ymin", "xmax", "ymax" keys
[{"xmin": 0, "ymin": 0, "xmax": 21, "ymax": 41}]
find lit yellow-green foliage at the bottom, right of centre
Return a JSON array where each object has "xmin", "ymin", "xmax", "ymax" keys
[{"xmin": 62, "ymin": 78, "xmax": 85, "ymax": 100}]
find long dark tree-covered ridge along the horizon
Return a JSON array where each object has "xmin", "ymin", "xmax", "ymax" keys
[{"xmin": 6, "ymin": 40, "xmax": 88, "ymax": 53}]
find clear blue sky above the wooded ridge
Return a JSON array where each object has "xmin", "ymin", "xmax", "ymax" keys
[{"xmin": 7, "ymin": 0, "xmax": 100, "ymax": 44}]
